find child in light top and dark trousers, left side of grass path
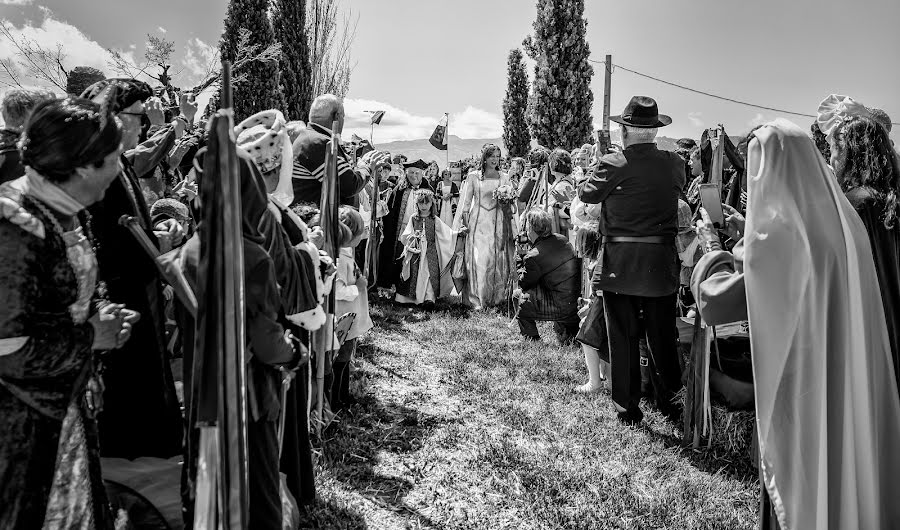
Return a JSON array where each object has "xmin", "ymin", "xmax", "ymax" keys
[{"xmin": 331, "ymin": 206, "xmax": 373, "ymax": 411}]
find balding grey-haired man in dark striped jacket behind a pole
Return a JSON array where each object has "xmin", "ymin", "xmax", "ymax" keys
[{"xmin": 291, "ymin": 94, "xmax": 387, "ymax": 208}]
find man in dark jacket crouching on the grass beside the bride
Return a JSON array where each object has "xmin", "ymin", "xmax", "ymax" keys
[{"xmin": 516, "ymin": 208, "xmax": 581, "ymax": 342}]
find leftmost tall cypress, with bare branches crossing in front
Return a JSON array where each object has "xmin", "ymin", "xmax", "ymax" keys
[{"xmin": 219, "ymin": 0, "xmax": 283, "ymax": 121}]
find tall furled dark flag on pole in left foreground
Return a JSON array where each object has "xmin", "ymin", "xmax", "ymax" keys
[{"xmin": 190, "ymin": 62, "xmax": 249, "ymax": 530}]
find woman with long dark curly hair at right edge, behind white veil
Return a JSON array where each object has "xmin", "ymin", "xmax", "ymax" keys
[{"xmin": 830, "ymin": 116, "xmax": 900, "ymax": 394}]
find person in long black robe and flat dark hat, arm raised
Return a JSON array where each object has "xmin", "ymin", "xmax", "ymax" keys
[{"xmin": 82, "ymin": 79, "xmax": 195, "ymax": 459}]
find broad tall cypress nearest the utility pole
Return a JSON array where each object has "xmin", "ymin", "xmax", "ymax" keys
[{"xmin": 523, "ymin": 0, "xmax": 594, "ymax": 149}]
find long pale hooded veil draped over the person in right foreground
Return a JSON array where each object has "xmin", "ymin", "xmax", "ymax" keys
[{"xmin": 744, "ymin": 120, "xmax": 900, "ymax": 530}]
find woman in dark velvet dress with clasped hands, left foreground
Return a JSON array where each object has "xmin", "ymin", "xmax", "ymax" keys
[{"xmin": 0, "ymin": 98, "xmax": 138, "ymax": 529}]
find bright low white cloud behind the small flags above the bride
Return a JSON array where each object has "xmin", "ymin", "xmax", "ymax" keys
[{"xmin": 344, "ymin": 98, "xmax": 503, "ymax": 142}]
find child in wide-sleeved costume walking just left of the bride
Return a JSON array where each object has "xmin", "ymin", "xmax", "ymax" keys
[{"xmin": 395, "ymin": 189, "xmax": 465, "ymax": 305}]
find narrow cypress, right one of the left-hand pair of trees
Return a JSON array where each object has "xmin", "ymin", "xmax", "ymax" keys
[{"xmin": 272, "ymin": 0, "xmax": 312, "ymax": 121}]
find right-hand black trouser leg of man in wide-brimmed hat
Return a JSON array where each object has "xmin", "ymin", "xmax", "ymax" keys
[{"xmin": 641, "ymin": 294, "xmax": 681, "ymax": 413}]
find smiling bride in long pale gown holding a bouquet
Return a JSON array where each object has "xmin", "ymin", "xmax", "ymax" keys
[{"xmin": 453, "ymin": 144, "xmax": 516, "ymax": 309}]
